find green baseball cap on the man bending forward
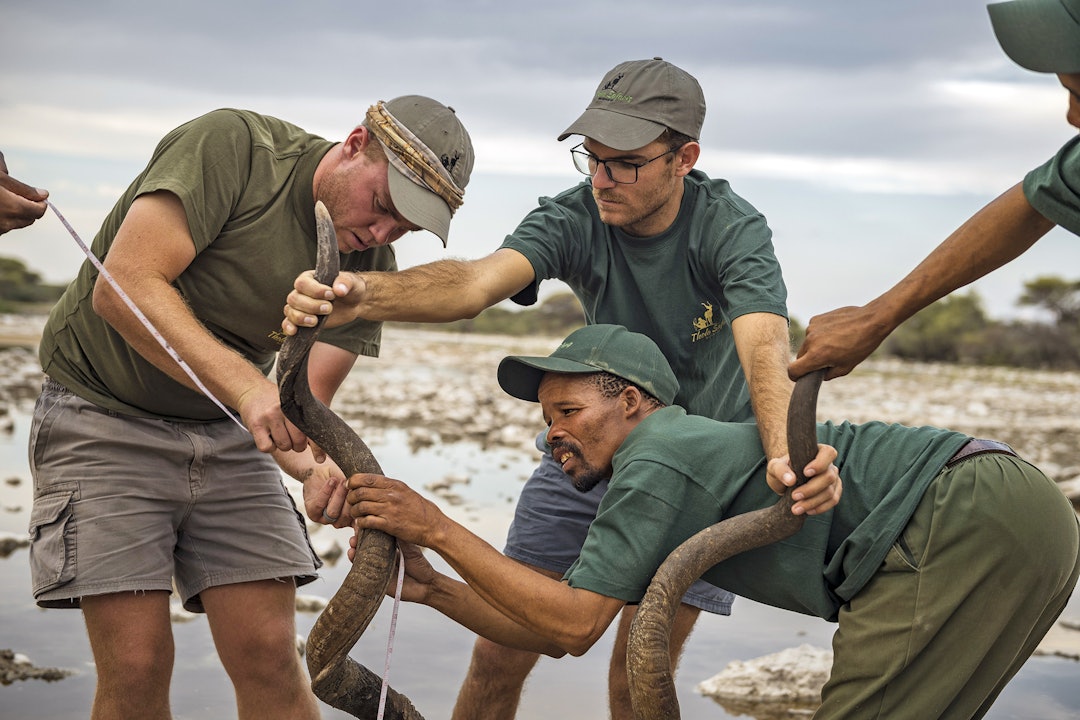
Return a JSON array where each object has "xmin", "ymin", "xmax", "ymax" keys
[{"xmin": 498, "ymin": 325, "xmax": 678, "ymax": 405}]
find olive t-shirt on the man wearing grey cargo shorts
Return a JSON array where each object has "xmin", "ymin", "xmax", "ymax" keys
[{"xmin": 39, "ymin": 109, "xmax": 396, "ymax": 421}]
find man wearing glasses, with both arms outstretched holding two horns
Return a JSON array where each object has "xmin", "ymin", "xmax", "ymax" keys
[{"xmin": 282, "ymin": 58, "xmax": 840, "ymax": 720}]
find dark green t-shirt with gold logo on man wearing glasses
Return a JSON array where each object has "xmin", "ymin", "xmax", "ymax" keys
[{"xmin": 502, "ymin": 171, "xmax": 787, "ymax": 421}]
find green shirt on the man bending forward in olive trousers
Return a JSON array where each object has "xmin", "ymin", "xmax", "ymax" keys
[{"xmin": 566, "ymin": 406, "xmax": 969, "ymax": 620}]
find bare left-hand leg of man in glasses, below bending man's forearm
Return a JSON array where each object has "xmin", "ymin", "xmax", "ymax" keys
[{"xmin": 450, "ymin": 563, "xmax": 563, "ymax": 720}]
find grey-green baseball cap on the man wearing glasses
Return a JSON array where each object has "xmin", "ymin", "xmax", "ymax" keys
[{"xmin": 558, "ymin": 57, "xmax": 705, "ymax": 150}]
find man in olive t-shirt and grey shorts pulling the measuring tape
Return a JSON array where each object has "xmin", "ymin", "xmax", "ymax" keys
[{"xmin": 30, "ymin": 95, "xmax": 473, "ymax": 720}]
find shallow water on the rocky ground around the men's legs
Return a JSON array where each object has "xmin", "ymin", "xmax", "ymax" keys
[{"xmin": 0, "ymin": 413, "xmax": 1080, "ymax": 720}]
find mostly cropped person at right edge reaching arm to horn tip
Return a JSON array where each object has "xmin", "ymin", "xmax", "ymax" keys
[{"xmin": 788, "ymin": 0, "xmax": 1080, "ymax": 379}]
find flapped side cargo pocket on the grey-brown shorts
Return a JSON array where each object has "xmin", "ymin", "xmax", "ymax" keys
[{"xmin": 30, "ymin": 485, "xmax": 76, "ymax": 597}]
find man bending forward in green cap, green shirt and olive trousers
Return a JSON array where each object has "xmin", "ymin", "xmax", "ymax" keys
[{"xmin": 349, "ymin": 325, "xmax": 1080, "ymax": 720}]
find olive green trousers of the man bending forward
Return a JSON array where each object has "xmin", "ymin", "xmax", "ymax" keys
[{"xmin": 814, "ymin": 454, "xmax": 1080, "ymax": 720}]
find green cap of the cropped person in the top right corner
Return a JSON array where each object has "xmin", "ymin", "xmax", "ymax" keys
[{"xmin": 986, "ymin": 0, "xmax": 1080, "ymax": 73}]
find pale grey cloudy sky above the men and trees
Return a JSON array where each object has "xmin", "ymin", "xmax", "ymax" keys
[{"xmin": 0, "ymin": 0, "xmax": 1080, "ymax": 322}]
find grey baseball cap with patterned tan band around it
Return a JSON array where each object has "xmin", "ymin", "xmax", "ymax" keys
[{"xmin": 383, "ymin": 95, "xmax": 474, "ymax": 247}]
